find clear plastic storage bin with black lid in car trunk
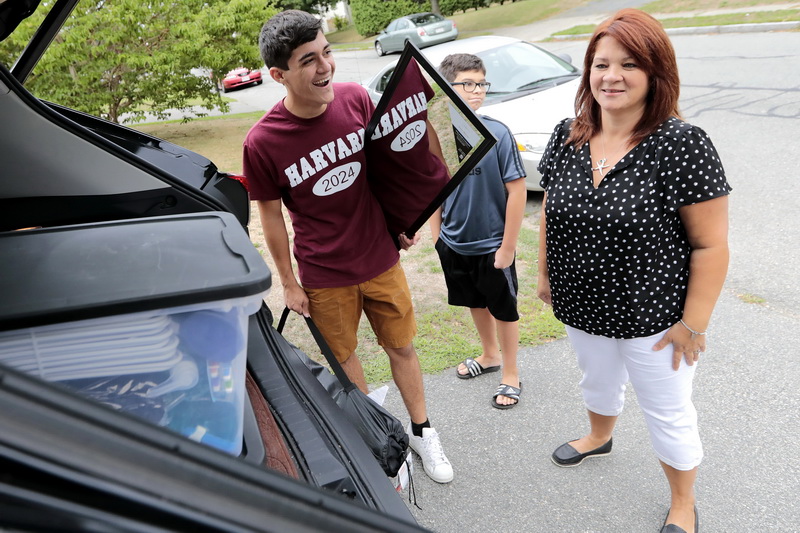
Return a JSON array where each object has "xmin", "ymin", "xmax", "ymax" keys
[{"xmin": 0, "ymin": 213, "xmax": 270, "ymax": 455}]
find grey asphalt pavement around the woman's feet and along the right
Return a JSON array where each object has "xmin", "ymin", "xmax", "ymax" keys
[{"xmin": 374, "ymin": 32, "xmax": 800, "ymax": 533}]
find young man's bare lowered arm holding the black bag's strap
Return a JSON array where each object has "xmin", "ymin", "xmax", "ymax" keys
[{"xmin": 256, "ymin": 200, "xmax": 310, "ymax": 317}]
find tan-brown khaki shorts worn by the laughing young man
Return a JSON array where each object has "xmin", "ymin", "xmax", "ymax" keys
[{"xmin": 305, "ymin": 261, "xmax": 417, "ymax": 363}]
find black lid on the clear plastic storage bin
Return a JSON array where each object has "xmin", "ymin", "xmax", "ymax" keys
[{"xmin": 0, "ymin": 212, "xmax": 271, "ymax": 331}]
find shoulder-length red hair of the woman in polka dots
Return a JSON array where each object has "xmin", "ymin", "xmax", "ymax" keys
[{"xmin": 567, "ymin": 8, "xmax": 681, "ymax": 148}]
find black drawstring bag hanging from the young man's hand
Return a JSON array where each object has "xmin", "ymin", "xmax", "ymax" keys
[{"xmin": 277, "ymin": 307, "xmax": 408, "ymax": 477}]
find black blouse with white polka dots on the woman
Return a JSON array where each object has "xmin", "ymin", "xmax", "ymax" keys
[{"xmin": 539, "ymin": 118, "xmax": 731, "ymax": 339}]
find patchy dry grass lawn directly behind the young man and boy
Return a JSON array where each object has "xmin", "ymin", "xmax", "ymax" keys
[{"xmin": 133, "ymin": 113, "xmax": 564, "ymax": 384}]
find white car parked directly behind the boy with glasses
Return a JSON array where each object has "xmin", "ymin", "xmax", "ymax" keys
[{"xmin": 363, "ymin": 36, "xmax": 580, "ymax": 191}]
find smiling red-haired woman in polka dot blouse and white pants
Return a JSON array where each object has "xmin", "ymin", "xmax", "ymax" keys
[{"xmin": 538, "ymin": 9, "xmax": 731, "ymax": 533}]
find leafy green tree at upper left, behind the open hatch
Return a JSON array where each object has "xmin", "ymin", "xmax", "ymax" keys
[{"xmin": 0, "ymin": 0, "xmax": 275, "ymax": 122}]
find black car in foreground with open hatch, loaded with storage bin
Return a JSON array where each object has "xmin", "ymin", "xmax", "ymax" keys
[{"xmin": 0, "ymin": 0, "xmax": 422, "ymax": 532}]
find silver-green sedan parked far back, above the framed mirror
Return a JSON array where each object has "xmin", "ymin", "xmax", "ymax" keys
[{"xmin": 375, "ymin": 13, "xmax": 458, "ymax": 56}]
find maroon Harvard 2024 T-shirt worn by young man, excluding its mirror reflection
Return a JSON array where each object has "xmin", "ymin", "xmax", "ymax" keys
[{"xmin": 244, "ymin": 83, "xmax": 399, "ymax": 288}]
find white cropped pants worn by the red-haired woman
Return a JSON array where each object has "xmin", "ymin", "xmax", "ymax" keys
[{"xmin": 567, "ymin": 326, "xmax": 703, "ymax": 470}]
